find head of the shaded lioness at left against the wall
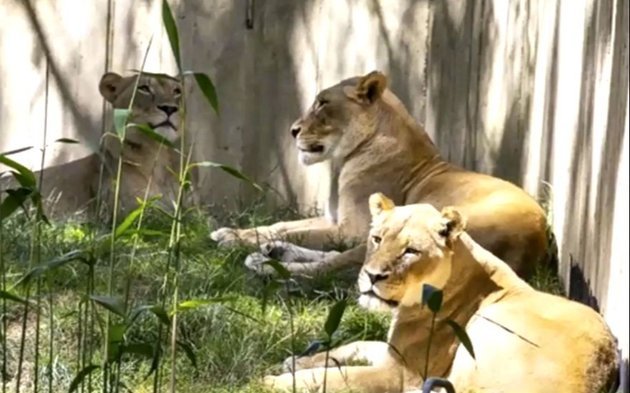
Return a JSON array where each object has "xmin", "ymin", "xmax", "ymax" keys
[{"xmin": 99, "ymin": 72, "xmax": 182, "ymax": 144}]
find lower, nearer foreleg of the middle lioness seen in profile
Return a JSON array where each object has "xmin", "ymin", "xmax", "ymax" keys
[{"xmin": 245, "ymin": 242, "xmax": 366, "ymax": 274}]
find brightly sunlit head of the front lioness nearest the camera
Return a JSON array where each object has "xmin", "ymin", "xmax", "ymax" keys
[{"xmin": 358, "ymin": 193, "xmax": 465, "ymax": 309}]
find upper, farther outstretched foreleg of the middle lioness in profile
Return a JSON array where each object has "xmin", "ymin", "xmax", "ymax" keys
[{"xmin": 210, "ymin": 217, "xmax": 338, "ymax": 247}]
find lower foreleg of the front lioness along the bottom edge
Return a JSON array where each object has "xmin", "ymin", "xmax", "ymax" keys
[{"xmin": 264, "ymin": 366, "xmax": 408, "ymax": 393}]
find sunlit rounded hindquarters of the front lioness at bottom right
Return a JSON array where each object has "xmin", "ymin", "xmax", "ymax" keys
[{"xmin": 449, "ymin": 290, "xmax": 609, "ymax": 393}]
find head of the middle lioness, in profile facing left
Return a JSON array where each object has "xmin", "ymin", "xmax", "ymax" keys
[{"xmin": 291, "ymin": 71, "xmax": 387, "ymax": 165}]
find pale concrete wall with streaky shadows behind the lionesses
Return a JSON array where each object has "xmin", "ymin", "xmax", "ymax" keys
[{"xmin": 0, "ymin": 0, "xmax": 629, "ymax": 382}]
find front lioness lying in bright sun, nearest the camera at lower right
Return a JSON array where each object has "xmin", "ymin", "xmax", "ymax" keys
[{"xmin": 265, "ymin": 194, "xmax": 617, "ymax": 393}]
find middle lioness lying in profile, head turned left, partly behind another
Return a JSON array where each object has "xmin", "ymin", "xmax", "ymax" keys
[{"xmin": 211, "ymin": 71, "xmax": 547, "ymax": 277}]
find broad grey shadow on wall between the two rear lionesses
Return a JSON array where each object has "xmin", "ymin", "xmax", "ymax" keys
[{"xmin": 176, "ymin": 0, "xmax": 314, "ymax": 208}]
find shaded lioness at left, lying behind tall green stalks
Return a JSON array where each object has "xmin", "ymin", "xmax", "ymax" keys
[{"xmin": 0, "ymin": 72, "xmax": 182, "ymax": 216}]
